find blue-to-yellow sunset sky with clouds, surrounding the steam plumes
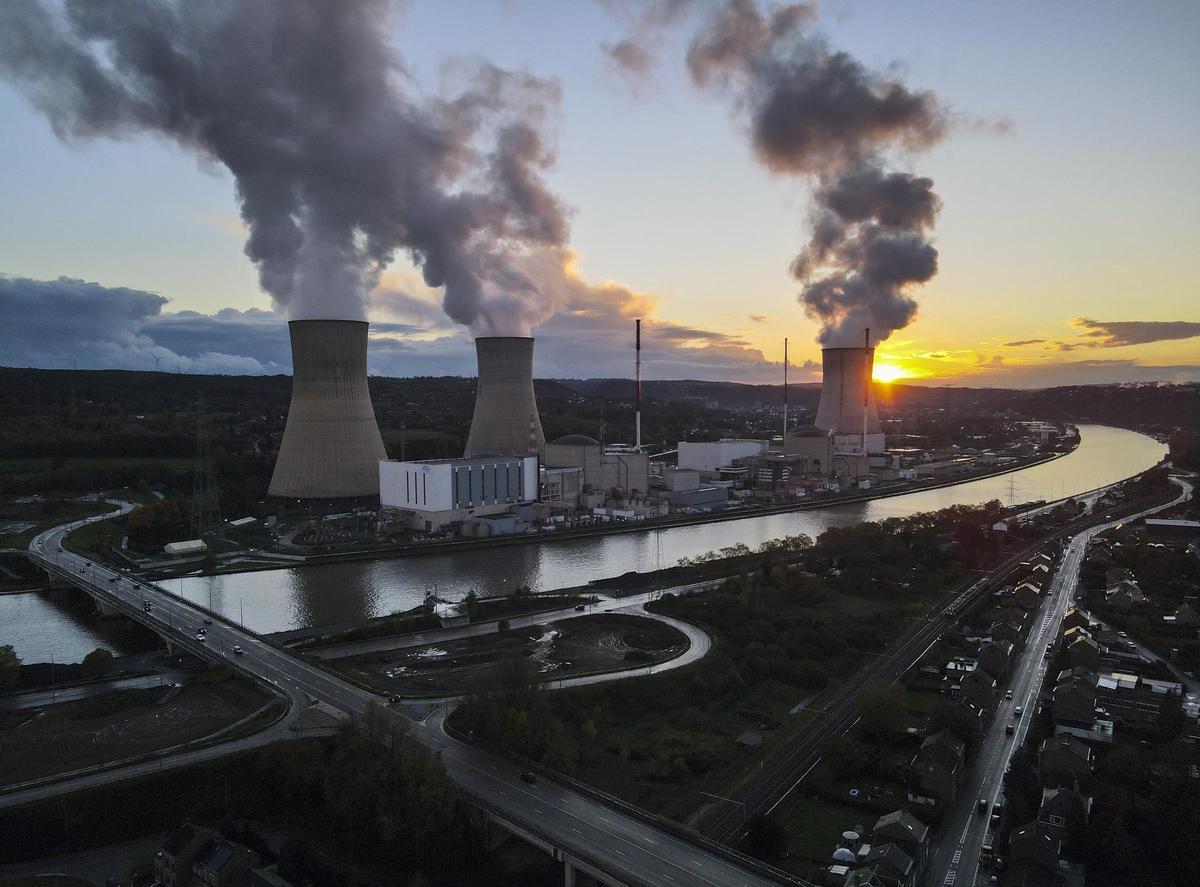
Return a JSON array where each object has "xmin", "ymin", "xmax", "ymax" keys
[{"xmin": 0, "ymin": 0, "xmax": 1200, "ymax": 388}]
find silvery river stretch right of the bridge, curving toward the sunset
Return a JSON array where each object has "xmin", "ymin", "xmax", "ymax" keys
[{"xmin": 159, "ymin": 425, "xmax": 1166, "ymax": 642}]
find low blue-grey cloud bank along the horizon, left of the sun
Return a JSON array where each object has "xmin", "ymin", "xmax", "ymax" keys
[{"xmin": 0, "ymin": 268, "xmax": 820, "ymax": 382}]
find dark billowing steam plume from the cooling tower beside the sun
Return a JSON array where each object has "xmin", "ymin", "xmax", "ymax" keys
[{"xmin": 688, "ymin": 0, "xmax": 948, "ymax": 344}]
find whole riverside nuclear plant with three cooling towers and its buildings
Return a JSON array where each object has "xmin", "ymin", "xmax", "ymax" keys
[{"xmin": 253, "ymin": 320, "xmax": 1070, "ymax": 541}]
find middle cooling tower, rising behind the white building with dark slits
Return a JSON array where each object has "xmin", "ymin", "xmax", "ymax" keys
[{"xmin": 463, "ymin": 336, "xmax": 546, "ymax": 456}]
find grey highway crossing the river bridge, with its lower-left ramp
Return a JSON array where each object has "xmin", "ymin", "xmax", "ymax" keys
[{"xmin": 16, "ymin": 505, "xmax": 786, "ymax": 887}]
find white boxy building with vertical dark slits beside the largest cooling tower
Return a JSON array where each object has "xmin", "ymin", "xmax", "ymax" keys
[{"xmin": 379, "ymin": 456, "xmax": 538, "ymax": 533}]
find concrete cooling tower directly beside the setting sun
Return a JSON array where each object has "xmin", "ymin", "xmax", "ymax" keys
[{"xmin": 814, "ymin": 348, "xmax": 884, "ymax": 453}]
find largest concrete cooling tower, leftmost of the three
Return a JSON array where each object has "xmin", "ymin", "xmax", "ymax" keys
[{"xmin": 268, "ymin": 320, "xmax": 388, "ymax": 499}]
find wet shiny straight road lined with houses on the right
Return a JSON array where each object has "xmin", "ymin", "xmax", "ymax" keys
[{"xmin": 928, "ymin": 481, "xmax": 1192, "ymax": 887}]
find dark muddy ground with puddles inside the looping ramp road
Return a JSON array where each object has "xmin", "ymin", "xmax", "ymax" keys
[{"xmin": 335, "ymin": 613, "xmax": 688, "ymax": 696}]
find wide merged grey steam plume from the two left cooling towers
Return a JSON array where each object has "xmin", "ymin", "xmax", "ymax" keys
[{"xmin": 0, "ymin": 0, "xmax": 568, "ymax": 334}]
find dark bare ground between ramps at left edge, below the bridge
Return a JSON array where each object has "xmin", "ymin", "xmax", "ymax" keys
[{"xmin": 0, "ymin": 679, "xmax": 269, "ymax": 785}]
